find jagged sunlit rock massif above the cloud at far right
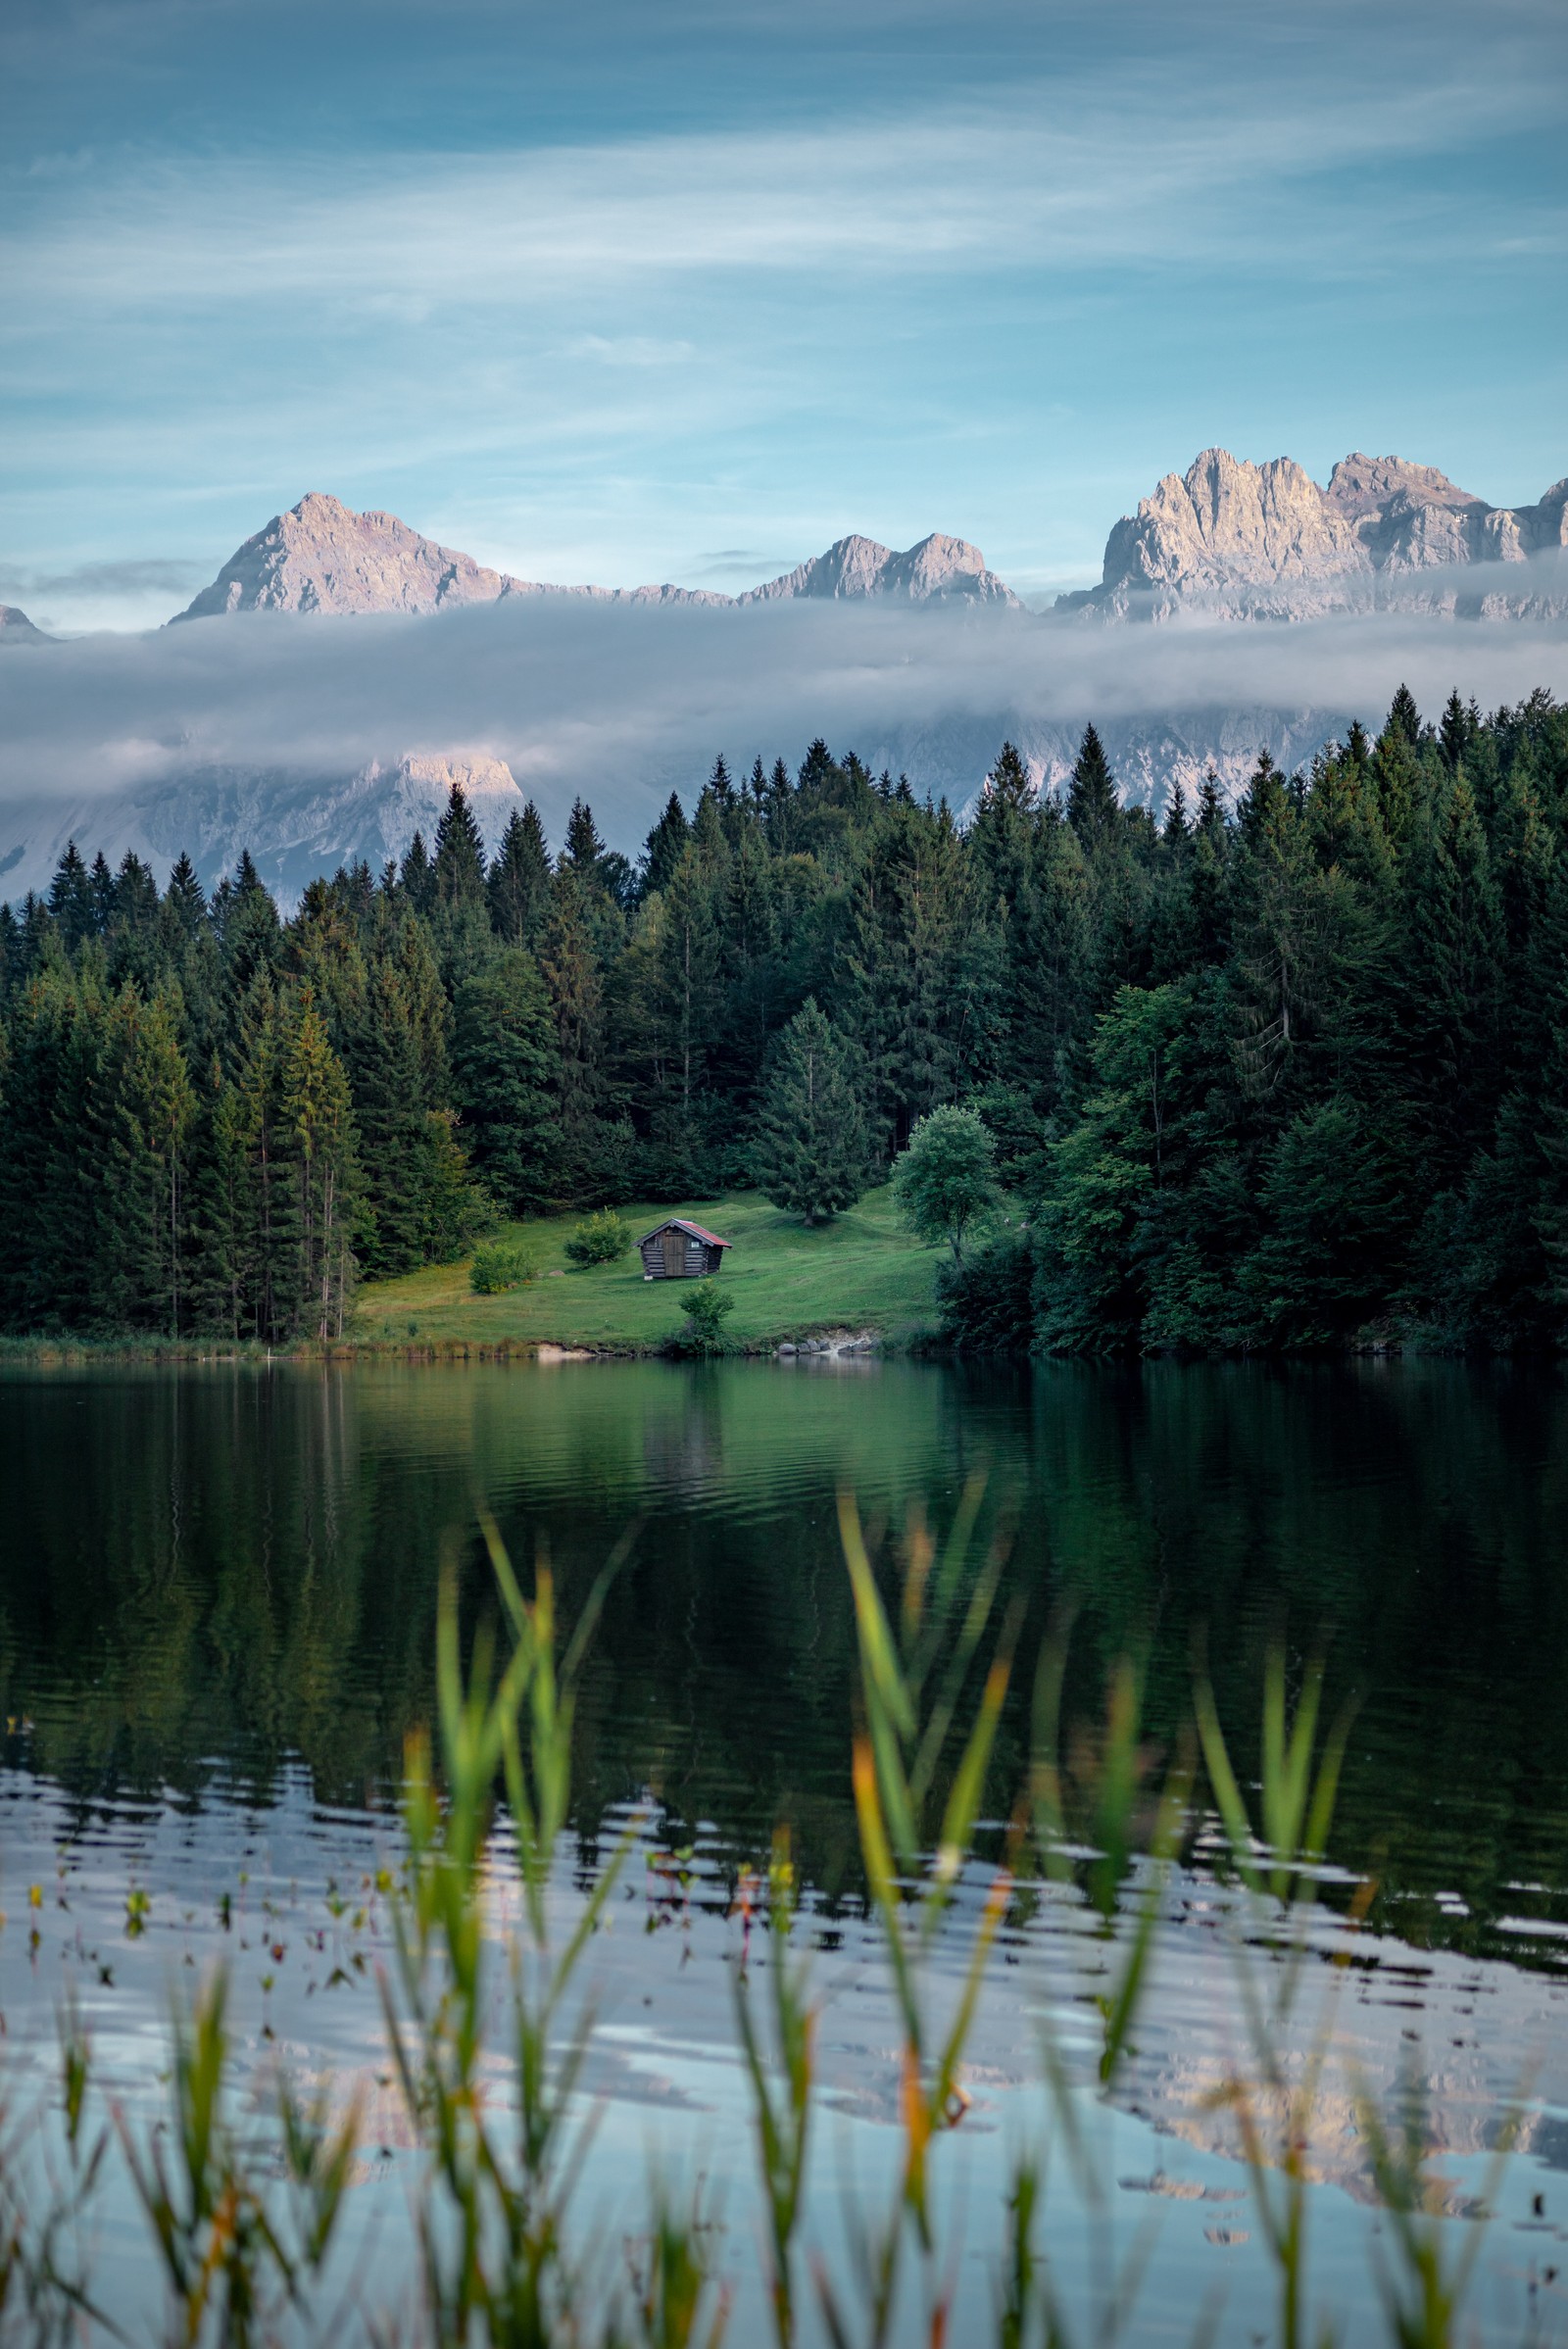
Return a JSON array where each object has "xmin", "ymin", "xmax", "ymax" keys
[{"xmin": 1065, "ymin": 449, "xmax": 1568, "ymax": 620}]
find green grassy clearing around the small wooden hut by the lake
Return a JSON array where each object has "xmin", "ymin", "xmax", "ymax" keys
[{"xmin": 350, "ymin": 1186, "xmax": 939, "ymax": 1353}]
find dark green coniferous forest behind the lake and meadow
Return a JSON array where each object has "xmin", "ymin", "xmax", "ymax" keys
[{"xmin": 0, "ymin": 688, "xmax": 1568, "ymax": 1350}]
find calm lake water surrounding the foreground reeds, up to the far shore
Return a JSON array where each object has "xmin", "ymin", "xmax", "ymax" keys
[{"xmin": 0, "ymin": 1362, "xmax": 1568, "ymax": 2339}]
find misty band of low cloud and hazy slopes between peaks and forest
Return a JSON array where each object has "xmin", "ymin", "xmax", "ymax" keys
[{"xmin": 0, "ymin": 596, "xmax": 1568, "ymax": 895}]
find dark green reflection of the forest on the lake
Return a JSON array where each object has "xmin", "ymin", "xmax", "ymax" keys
[{"xmin": 0, "ymin": 1362, "xmax": 1568, "ymax": 1969}]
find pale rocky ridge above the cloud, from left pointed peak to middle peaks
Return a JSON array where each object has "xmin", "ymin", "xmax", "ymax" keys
[{"xmin": 176, "ymin": 491, "xmax": 1019, "ymax": 620}]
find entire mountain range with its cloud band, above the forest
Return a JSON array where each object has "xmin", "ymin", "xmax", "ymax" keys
[{"xmin": 0, "ymin": 449, "xmax": 1568, "ymax": 898}]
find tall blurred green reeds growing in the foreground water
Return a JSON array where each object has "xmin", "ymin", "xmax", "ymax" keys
[{"xmin": 0, "ymin": 1480, "xmax": 1540, "ymax": 2349}]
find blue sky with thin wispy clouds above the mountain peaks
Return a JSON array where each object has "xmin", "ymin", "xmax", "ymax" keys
[{"xmin": 0, "ymin": 0, "xmax": 1568, "ymax": 627}]
